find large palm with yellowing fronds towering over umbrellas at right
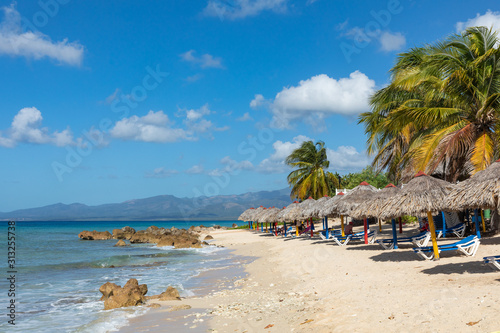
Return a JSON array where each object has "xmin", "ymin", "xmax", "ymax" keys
[{"xmin": 359, "ymin": 27, "xmax": 500, "ymax": 181}]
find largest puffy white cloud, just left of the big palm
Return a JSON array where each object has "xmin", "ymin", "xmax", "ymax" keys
[{"xmin": 270, "ymin": 71, "xmax": 375, "ymax": 128}]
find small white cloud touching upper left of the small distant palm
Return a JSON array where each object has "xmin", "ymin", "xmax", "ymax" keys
[{"xmin": 257, "ymin": 135, "xmax": 312, "ymax": 173}]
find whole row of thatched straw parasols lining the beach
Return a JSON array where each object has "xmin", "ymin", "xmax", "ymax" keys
[{"xmin": 238, "ymin": 160, "xmax": 500, "ymax": 258}]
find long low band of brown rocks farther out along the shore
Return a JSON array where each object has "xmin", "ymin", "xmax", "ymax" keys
[{"xmin": 78, "ymin": 225, "xmax": 227, "ymax": 248}]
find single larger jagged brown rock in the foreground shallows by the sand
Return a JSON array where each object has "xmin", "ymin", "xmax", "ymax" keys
[{"xmin": 99, "ymin": 279, "xmax": 148, "ymax": 310}]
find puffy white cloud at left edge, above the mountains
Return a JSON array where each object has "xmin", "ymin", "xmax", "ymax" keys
[{"xmin": 0, "ymin": 107, "xmax": 75, "ymax": 148}]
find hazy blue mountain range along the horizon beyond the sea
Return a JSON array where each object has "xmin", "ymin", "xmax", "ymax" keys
[{"xmin": 0, "ymin": 188, "xmax": 291, "ymax": 221}]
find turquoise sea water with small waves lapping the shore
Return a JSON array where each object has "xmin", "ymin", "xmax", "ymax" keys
[{"xmin": 0, "ymin": 221, "xmax": 237, "ymax": 333}]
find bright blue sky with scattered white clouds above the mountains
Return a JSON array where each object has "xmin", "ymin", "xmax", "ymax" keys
[{"xmin": 0, "ymin": 0, "xmax": 500, "ymax": 212}]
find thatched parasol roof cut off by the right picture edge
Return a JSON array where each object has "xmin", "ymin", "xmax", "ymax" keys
[{"xmin": 446, "ymin": 160, "xmax": 500, "ymax": 211}]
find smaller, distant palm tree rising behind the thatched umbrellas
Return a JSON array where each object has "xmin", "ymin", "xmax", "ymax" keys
[{"xmin": 285, "ymin": 141, "xmax": 338, "ymax": 199}]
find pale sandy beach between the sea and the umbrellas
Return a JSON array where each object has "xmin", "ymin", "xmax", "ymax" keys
[{"xmin": 120, "ymin": 225, "xmax": 500, "ymax": 332}]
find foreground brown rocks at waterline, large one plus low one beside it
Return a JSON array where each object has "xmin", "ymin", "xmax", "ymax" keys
[{"xmin": 99, "ymin": 279, "xmax": 181, "ymax": 310}]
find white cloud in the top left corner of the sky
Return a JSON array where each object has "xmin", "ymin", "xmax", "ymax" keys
[{"xmin": 0, "ymin": 3, "xmax": 84, "ymax": 66}]
